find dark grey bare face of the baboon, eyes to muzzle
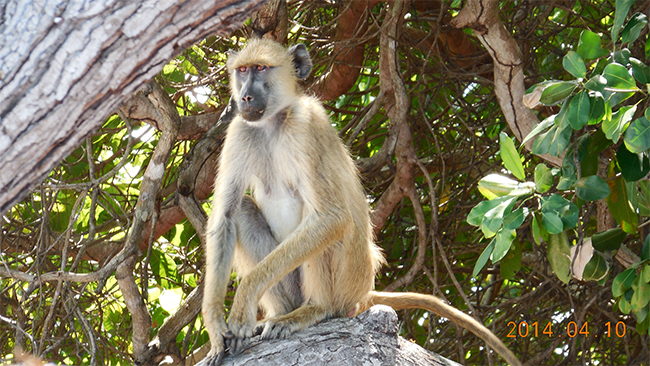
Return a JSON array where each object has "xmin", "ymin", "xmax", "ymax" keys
[{"xmin": 235, "ymin": 65, "xmax": 271, "ymax": 122}]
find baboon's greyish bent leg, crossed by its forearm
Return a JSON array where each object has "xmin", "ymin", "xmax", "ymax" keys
[{"xmin": 234, "ymin": 196, "xmax": 304, "ymax": 317}]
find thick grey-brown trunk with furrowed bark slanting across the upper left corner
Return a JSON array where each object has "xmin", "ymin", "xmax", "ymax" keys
[{"xmin": 0, "ymin": 0, "xmax": 263, "ymax": 213}]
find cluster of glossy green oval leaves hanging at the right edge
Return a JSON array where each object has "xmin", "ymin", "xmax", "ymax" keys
[{"xmin": 467, "ymin": 1, "xmax": 650, "ymax": 352}]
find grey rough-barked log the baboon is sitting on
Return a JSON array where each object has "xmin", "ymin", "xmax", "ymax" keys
[{"xmin": 197, "ymin": 305, "xmax": 460, "ymax": 366}]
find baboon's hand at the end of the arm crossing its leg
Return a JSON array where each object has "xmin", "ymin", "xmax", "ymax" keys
[{"xmin": 224, "ymin": 285, "xmax": 257, "ymax": 354}]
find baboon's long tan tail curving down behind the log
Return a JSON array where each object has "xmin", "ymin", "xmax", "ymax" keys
[{"xmin": 363, "ymin": 291, "xmax": 521, "ymax": 366}]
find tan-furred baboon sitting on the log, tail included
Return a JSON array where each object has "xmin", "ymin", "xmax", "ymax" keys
[{"xmin": 203, "ymin": 39, "xmax": 520, "ymax": 365}]
